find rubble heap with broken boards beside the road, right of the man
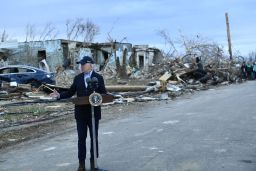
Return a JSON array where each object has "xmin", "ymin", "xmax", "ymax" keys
[{"xmin": 96, "ymin": 57, "xmax": 242, "ymax": 104}]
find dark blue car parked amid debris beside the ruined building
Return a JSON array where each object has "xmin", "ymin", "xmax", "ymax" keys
[{"xmin": 0, "ymin": 65, "xmax": 55, "ymax": 86}]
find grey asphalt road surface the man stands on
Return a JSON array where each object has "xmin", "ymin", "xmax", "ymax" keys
[{"xmin": 0, "ymin": 81, "xmax": 256, "ymax": 171}]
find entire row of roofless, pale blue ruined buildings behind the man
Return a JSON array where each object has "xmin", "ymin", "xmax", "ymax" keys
[{"xmin": 0, "ymin": 39, "xmax": 163, "ymax": 75}]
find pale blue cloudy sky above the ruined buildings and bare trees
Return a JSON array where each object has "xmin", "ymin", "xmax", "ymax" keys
[{"xmin": 0, "ymin": 0, "xmax": 256, "ymax": 56}]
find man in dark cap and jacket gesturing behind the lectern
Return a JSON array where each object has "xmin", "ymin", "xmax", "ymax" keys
[{"xmin": 50, "ymin": 56, "xmax": 107, "ymax": 171}]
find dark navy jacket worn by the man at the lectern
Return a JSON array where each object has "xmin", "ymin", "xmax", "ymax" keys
[{"xmin": 60, "ymin": 71, "xmax": 107, "ymax": 120}]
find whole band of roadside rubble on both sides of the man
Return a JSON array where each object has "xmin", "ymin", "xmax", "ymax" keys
[{"xmin": 0, "ymin": 54, "xmax": 245, "ymax": 134}]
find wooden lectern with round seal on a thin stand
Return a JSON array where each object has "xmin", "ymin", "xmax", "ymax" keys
[{"xmin": 71, "ymin": 91, "xmax": 114, "ymax": 170}]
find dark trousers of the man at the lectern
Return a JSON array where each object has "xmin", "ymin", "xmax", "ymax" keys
[{"xmin": 76, "ymin": 119, "xmax": 99, "ymax": 161}]
